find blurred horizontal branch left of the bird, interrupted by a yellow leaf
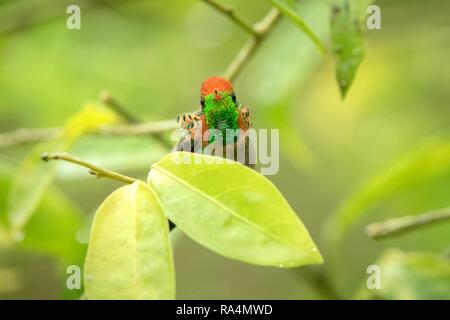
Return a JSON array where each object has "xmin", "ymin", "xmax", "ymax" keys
[{"xmin": 0, "ymin": 120, "xmax": 179, "ymax": 148}]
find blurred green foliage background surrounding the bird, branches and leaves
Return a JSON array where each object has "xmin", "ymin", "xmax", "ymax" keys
[{"xmin": 0, "ymin": 0, "xmax": 450, "ymax": 299}]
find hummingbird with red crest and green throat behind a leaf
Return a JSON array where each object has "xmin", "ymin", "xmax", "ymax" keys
[{"xmin": 174, "ymin": 77, "xmax": 255, "ymax": 168}]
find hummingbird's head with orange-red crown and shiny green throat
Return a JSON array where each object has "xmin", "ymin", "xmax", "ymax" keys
[{"xmin": 200, "ymin": 77, "xmax": 238, "ymax": 133}]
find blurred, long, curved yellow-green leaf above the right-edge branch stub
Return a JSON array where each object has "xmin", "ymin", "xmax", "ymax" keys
[{"xmin": 328, "ymin": 140, "xmax": 450, "ymax": 244}]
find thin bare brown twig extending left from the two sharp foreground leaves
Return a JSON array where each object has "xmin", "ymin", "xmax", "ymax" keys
[{"xmin": 41, "ymin": 152, "xmax": 136, "ymax": 184}]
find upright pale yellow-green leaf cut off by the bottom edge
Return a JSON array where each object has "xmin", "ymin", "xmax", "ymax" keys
[{"xmin": 85, "ymin": 181, "xmax": 175, "ymax": 299}]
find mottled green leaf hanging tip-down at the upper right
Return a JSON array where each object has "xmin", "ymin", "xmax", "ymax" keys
[{"xmin": 331, "ymin": 0, "xmax": 365, "ymax": 98}]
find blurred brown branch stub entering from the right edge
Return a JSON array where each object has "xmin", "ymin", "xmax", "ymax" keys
[{"xmin": 366, "ymin": 207, "xmax": 450, "ymax": 240}]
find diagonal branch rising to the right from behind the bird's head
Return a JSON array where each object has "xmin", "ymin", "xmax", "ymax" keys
[{"xmin": 224, "ymin": 8, "xmax": 281, "ymax": 80}]
